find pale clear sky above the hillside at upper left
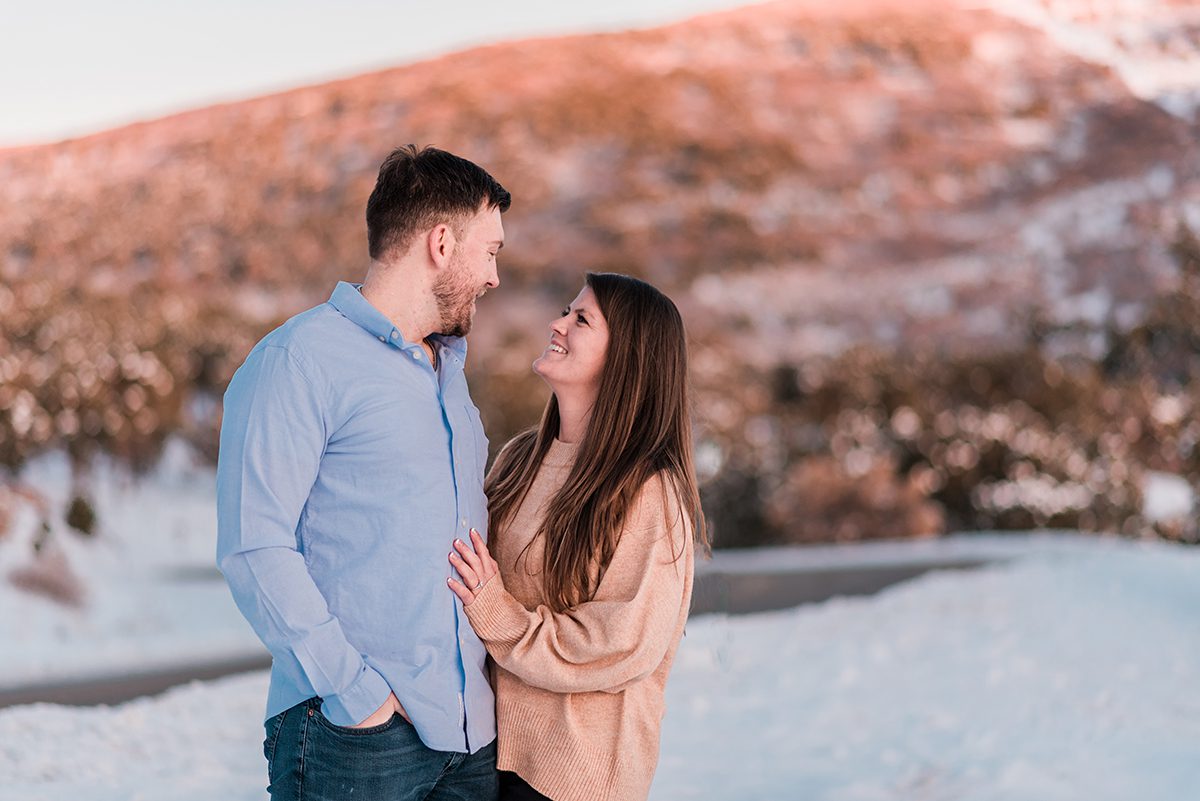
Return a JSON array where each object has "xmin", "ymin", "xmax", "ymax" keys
[{"xmin": 0, "ymin": 0, "xmax": 750, "ymax": 146}]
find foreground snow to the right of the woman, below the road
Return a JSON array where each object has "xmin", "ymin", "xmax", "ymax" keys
[{"xmin": 655, "ymin": 534, "xmax": 1200, "ymax": 801}]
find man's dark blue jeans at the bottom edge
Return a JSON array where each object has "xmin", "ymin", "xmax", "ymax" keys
[{"xmin": 263, "ymin": 698, "xmax": 498, "ymax": 801}]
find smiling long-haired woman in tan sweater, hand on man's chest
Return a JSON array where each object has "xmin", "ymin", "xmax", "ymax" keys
[{"xmin": 449, "ymin": 273, "xmax": 707, "ymax": 801}]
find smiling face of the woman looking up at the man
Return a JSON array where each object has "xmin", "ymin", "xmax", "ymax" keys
[{"xmin": 533, "ymin": 287, "xmax": 608, "ymax": 401}]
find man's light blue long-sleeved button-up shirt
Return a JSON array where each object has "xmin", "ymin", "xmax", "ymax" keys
[{"xmin": 217, "ymin": 282, "xmax": 496, "ymax": 752}]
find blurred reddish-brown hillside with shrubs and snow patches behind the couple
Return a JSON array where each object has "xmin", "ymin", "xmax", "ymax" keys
[{"xmin": 0, "ymin": 0, "xmax": 1200, "ymax": 544}]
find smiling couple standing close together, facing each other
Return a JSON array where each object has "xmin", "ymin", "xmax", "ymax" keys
[{"xmin": 217, "ymin": 146, "xmax": 706, "ymax": 801}]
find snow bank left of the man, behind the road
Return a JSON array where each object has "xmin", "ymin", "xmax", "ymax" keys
[{"xmin": 0, "ymin": 442, "xmax": 265, "ymax": 688}]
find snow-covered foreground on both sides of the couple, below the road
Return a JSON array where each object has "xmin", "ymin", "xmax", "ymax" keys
[{"xmin": 0, "ymin": 540, "xmax": 1200, "ymax": 801}]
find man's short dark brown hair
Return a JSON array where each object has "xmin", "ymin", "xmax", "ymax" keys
[{"xmin": 367, "ymin": 145, "xmax": 512, "ymax": 259}]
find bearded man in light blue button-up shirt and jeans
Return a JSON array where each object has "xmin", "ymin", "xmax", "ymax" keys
[{"xmin": 217, "ymin": 146, "xmax": 510, "ymax": 801}]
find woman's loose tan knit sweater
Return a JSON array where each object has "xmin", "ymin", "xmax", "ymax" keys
[{"xmin": 466, "ymin": 440, "xmax": 694, "ymax": 801}]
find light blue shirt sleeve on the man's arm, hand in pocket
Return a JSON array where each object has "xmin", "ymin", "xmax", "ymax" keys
[{"xmin": 217, "ymin": 345, "xmax": 391, "ymax": 725}]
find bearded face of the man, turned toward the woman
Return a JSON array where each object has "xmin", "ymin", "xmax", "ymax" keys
[{"xmin": 433, "ymin": 209, "xmax": 504, "ymax": 337}]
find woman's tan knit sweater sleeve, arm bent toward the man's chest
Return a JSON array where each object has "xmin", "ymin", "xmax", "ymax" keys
[{"xmin": 464, "ymin": 478, "xmax": 691, "ymax": 693}]
